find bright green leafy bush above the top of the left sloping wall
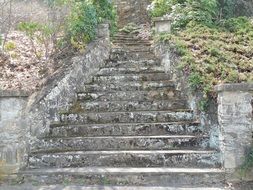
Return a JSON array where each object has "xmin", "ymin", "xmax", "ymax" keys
[{"xmin": 58, "ymin": 0, "xmax": 117, "ymax": 51}]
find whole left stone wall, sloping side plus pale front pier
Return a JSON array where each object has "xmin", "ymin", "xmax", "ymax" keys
[{"xmin": 0, "ymin": 24, "xmax": 110, "ymax": 174}]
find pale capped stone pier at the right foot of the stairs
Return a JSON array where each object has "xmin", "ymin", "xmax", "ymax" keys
[{"xmin": 215, "ymin": 83, "xmax": 253, "ymax": 177}]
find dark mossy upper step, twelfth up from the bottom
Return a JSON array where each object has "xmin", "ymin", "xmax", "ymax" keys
[{"xmin": 110, "ymin": 48, "xmax": 156, "ymax": 61}]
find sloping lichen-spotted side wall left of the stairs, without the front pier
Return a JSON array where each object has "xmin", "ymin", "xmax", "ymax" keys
[{"xmin": 27, "ymin": 24, "xmax": 110, "ymax": 138}]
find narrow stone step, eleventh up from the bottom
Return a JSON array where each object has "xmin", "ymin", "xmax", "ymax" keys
[{"xmin": 105, "ymin": 59, "xmax": 161, "ymax": 68}]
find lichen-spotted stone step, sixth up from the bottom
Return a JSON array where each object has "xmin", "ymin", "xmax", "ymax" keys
[{"xmin": 78, "ymin": 99, "xmax": 187, "ymax": 113}]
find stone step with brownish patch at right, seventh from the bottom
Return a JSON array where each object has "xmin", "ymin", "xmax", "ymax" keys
[{"xmin": 77, "ymin": 89, "xmax": 181, "ymax": 101}]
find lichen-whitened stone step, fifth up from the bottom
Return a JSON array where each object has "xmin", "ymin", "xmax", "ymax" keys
[{"xmin": 60, "ymin": 110, "xmax": 194, "ymax": 124}]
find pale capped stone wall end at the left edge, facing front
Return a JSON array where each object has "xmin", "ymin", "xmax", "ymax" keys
[{"xmin": 0, "ymin": 91, "xmax": 29, "ymax": 172}]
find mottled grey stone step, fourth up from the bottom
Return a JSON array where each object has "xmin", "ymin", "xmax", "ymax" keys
[{"xmin": 49, "ymin": 122, "xmax": 203, "ymax": 137}]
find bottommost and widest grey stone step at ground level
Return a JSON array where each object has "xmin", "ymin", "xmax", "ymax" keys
[{"xmin": 20, "ymin": 167, "xmax": 225, "ymax": 186}]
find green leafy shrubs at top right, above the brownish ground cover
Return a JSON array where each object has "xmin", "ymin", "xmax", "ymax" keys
[{"xmin": 149, "ymin": 0, "xmax": 250, "ymax": 31}]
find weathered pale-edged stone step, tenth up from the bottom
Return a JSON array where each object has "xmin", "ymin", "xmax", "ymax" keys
[{"xmin": 97, "ymin": 66, "xmax": 165, "ymax": 75}]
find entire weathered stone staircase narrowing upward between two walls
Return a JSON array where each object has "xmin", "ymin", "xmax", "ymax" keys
[{"xmin": 22, "ymin": 31, "xmax": 224, "ymax": 189}]
